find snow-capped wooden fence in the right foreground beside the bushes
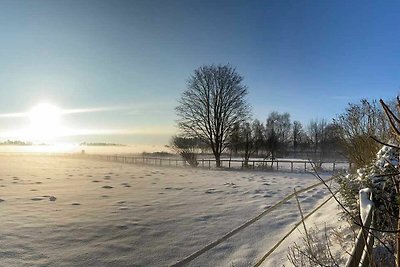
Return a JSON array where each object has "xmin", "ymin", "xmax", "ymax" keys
[{"xmin": 346, "ymin": 189, "xmax": 374, "ymax": 267}]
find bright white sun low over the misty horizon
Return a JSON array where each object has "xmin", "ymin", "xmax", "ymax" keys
[{"xmin": 27, "ymin": 103, "xmax": 63, "ymax": 142}]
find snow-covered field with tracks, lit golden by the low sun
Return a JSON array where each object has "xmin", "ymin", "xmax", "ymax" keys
[{"xmin": 0, "ymin": 156, "xmax": 342, "ymax": 266}]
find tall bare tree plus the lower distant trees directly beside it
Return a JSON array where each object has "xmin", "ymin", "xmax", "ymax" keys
[{"xmin": 171, "ymin": 65, "xmax": 344, "ymax": 166}]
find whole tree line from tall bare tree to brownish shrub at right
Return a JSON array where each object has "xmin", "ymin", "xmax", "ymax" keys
[{"xmin": 171, "ymin": 65, "xmax": 394, "ymax": 167}]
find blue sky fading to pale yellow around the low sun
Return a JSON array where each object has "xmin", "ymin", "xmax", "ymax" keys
[{"xmin": 0, "ymin": 0, "xmax": 400, "ymax": 150}]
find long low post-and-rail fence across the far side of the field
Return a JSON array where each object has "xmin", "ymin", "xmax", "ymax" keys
[{"xmin": 82, "ymin": 154, "xmax": 351, "ymax": 172}]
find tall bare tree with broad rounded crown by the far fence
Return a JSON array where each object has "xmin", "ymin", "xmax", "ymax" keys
[{"xmin": 176, "ymin": 65, "xmax": 250, "ymax": 167}]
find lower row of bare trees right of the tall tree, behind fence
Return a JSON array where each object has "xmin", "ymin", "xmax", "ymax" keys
[{"xmin": 229, "ymin": 115, "xmax": 339, "ymax": 163}]
